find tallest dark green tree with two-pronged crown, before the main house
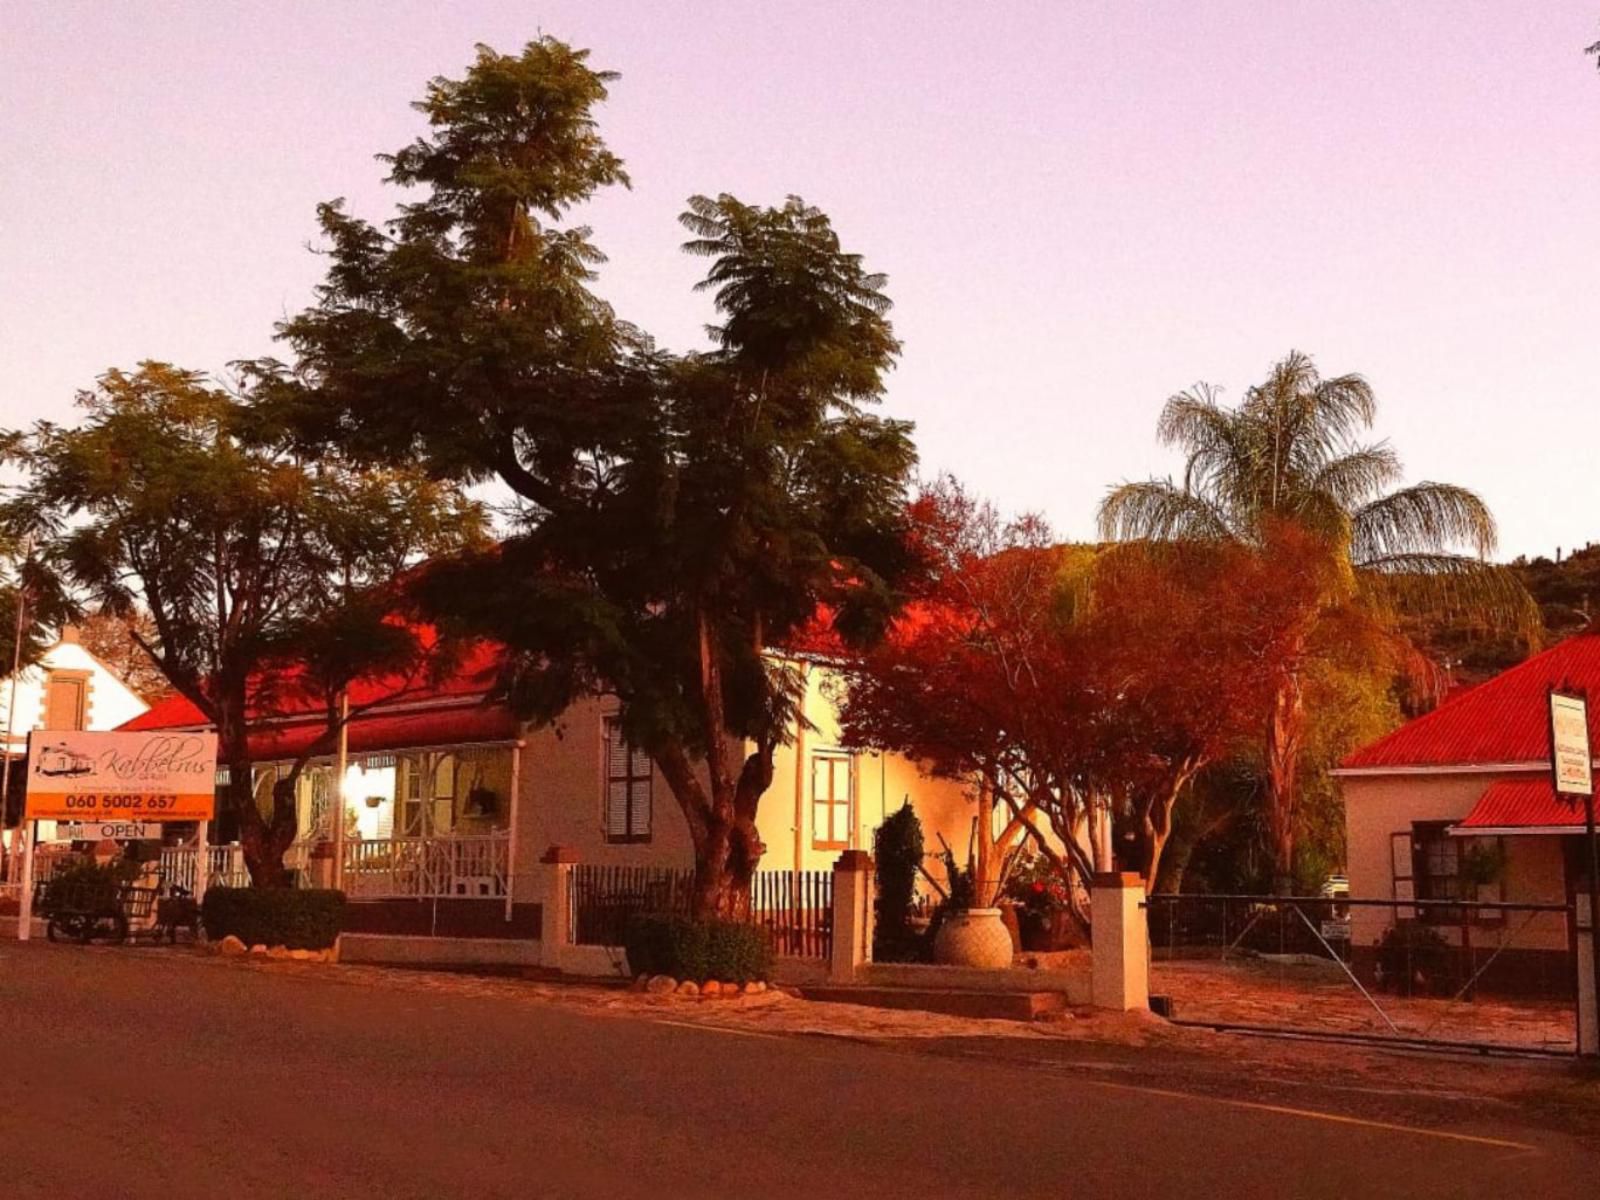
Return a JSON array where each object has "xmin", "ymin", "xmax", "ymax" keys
[{"xmin": 258, "ymin": 37, "xmax": 914, "ymax": 914}]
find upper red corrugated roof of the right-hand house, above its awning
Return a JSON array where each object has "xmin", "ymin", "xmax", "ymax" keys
[{"xmin": 1344, "ymin": 634, "xmax": 1600, "ymax": 770}]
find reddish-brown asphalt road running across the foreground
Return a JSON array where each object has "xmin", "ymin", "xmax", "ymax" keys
[{"xmin": 0, "ymin": 944, "xmax": 1600, "ymax": 1200}]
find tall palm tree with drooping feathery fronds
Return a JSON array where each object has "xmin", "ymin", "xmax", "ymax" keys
[{"xmin": 1099, "ymin": 352, "xmax": 1538, "ymax": 893}]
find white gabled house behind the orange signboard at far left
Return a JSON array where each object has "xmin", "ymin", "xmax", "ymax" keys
[{"xmin": 0, "ymin": 626, "xmax": 149, "ymax": 842}]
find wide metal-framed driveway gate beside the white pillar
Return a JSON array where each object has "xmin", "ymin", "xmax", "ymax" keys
[{"xmin": 1147, "ymin": 894, "xmax": 1578, "ymax": 1054}]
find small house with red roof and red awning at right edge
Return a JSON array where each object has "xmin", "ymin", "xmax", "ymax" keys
[{"xmin": 1334, "ymin": 634, "xmax": 1600, "ymax": 990}]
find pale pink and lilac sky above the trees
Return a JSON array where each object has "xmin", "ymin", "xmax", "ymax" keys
[{"xmin": 0, "ymin": 0, "xmax": 1600, "ymax": 557}]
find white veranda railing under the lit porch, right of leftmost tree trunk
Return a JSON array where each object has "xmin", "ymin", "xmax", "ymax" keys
[{"xmin": 344, "ymin": 832, "xmax": 510, "ymax": 899}]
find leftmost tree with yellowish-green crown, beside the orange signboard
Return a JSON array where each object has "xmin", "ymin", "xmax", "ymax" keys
[{"xmin": 0, "ymin": 363, "xmax": 482, "ymax": 885}]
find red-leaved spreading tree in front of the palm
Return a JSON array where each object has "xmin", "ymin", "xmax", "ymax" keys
[{"xmin": 838, "ymin": 480, "xmax": 1305, "ymax": 894}]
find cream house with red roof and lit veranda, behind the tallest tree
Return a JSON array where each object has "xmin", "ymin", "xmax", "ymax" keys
[{"xmin": 125, "ymin": 643, "xmax": 974, "ymax": 938}]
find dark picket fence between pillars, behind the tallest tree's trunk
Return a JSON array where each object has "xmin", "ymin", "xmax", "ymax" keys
[{"xmin": 570, "ymin": 864, "xmax": 834, "ymax": 958}]
